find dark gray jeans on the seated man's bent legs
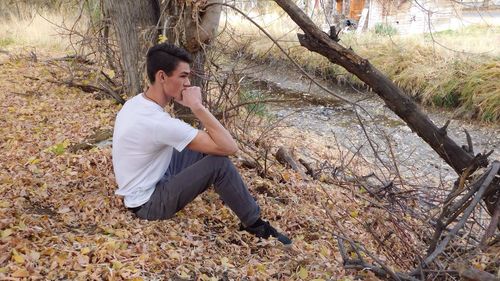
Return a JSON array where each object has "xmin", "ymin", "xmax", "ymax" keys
[{"xmin": 136, "ymin": 148, "xmax": 260, "ymax": 226}]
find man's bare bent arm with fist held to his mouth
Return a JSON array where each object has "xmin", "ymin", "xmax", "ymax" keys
[{"xmin": 176, "ymin": 87, "xmax": 238, "ymax": 156}]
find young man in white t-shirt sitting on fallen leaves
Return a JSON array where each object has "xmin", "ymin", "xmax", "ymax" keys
[{"xmin": 113, "ymin": 43, "xmax": 292, "ymax": 245}]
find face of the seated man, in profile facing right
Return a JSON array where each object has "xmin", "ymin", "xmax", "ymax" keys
[{"xmin": 161, "ymin": 61, "xmax": 191, "ymax": 99}]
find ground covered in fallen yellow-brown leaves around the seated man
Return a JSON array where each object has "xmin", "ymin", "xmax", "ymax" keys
[{"xmin": 0, "ymin": 52, "xmax": 454, "ymax": 280}]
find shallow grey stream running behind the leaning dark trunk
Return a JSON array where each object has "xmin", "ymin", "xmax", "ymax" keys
[{"xmin": 230, "ymin": 62, "xmax": 500, "ymax": 187}]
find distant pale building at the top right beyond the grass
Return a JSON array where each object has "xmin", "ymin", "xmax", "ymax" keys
[{"xmin": 335, "ymin": 0, "xmax": 500, "ymax": 34}]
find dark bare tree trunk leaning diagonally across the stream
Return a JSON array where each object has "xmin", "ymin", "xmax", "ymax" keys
[{"xmin": 275, "ymin": 0, "xmax": 487, "ymax": 175}]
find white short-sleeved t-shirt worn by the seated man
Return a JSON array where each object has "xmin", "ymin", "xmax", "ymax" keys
[{"xmin": 113, "ymin": 94, "xmax": 198, "ymax": 208}]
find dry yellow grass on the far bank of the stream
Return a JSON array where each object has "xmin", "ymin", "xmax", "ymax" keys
[{"xmin": 221, "ymin": 11, "xmax": 500, "ymax": 122}]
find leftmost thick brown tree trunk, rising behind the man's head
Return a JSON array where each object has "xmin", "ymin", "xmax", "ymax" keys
[{"xmin": 104, "ymin": 0, "xmax": 160, "ymax": 96}]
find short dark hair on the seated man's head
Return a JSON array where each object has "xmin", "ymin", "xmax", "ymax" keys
[{"xmin": 146, "ymin": 43, "xmax": 192, "ymax": 83}]
